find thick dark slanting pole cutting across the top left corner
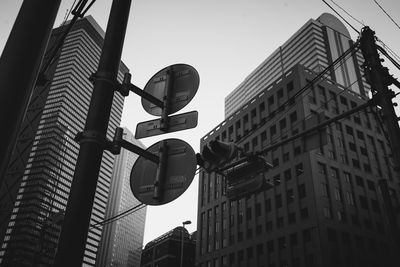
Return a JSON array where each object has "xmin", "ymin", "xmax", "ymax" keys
[{"xmin": 0, "ymin": 0, "xmax": 61, "ymax": 185}]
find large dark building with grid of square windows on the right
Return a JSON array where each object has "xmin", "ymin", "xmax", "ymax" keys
[{"xmin": 196, "ymin": 15, "xmax": 400, "ymax": 267}]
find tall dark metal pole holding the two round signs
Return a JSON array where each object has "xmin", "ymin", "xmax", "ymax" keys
[{"xmin": 54, "ymin": 0, "xmax": 131, "ymax": 266}]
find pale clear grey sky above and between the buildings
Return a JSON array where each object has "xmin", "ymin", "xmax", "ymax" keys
[{"xmin": 0, "ymin": 0, "xmax": 400, "ymax": 245}]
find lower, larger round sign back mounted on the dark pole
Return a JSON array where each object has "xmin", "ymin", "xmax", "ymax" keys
[{"xmin": 130, "ymin": 139, "xmax": 196, "ymax": 205}]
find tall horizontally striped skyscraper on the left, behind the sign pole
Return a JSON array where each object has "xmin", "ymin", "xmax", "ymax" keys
[{"xmin": 0, "ymin": 16, "xmax": 127, "ymax": 266}]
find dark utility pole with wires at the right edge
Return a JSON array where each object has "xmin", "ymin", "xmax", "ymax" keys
[{"xmin": 360, "ymin": 27, "xmax": 400, "ymax": 170}]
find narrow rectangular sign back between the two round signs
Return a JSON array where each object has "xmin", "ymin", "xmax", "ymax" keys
[{"xmin": 135, "ymin": 111, "xmax": 198, "ymax": 139}]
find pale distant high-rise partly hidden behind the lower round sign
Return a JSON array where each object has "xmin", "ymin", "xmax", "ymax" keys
[{"xmin": 96, "ymin": 128, "xmax": 146, "ymax": 267}]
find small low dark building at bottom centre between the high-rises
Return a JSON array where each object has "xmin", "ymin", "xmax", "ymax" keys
[{"xmin": 140, "ymin": 226, "xmax": 196, "ymax": 267}]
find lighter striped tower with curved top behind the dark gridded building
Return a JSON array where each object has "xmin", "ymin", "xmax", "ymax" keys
[{"xmin": 225, "ymin": 13, "xmax": 370, "ymax": 118}]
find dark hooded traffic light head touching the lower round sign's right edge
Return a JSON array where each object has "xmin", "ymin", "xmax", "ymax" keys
[{"xmin": 196, "ymin": 140, "xmax": 240, "ymax": 172}]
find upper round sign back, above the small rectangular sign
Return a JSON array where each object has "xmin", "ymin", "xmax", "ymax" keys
[{"xmin": 142, "ymin": 64, "xmax": 200, "ymax": 116}]
